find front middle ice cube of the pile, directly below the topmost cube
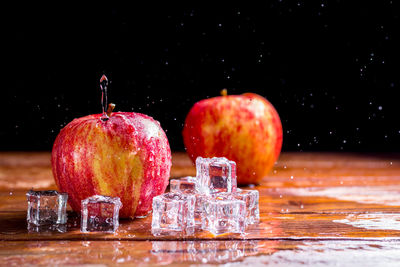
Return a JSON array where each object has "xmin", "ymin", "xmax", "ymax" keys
[{"xmin": 201, "ymin": 193, "xmax": 246, "ymax": 235}]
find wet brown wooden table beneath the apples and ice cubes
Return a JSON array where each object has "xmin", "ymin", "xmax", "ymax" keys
[{"xmin": 0, "ymin": 152, "xmax": 400, "ymax": 266}]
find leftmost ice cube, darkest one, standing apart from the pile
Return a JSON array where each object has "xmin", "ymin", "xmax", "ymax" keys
[{"xmin": 26, "ymin": 190, "xmax": 68, "ymax": 226}]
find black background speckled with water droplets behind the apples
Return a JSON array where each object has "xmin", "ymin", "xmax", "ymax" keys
[{"xmin": 0, "ymin": 3, "xmax": 400, "ymax": 152}]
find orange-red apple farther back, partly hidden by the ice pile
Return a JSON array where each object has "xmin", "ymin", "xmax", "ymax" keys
[{"xmin": 183, "ymin": 93, "xmax": 282, "ymax": 185}]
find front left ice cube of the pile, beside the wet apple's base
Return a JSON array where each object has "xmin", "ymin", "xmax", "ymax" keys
[{"xmin": 151, "ymin": 192, "xmax": 196, "ymax": 235}]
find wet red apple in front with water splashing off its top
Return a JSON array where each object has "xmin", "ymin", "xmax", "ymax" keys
[{"xmin": 51, "ymin": 112, "xmax": 171, "ymax": 218}]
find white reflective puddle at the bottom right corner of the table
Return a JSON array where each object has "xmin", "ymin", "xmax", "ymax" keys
[{"xmin": 222, "ymin": 241, "xmax": 400, "ymax": 267}]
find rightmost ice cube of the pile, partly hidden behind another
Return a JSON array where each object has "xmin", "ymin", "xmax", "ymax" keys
[{"xmin": 235, "ymin": 190, "xmax": 260, "ymax": 226}]
